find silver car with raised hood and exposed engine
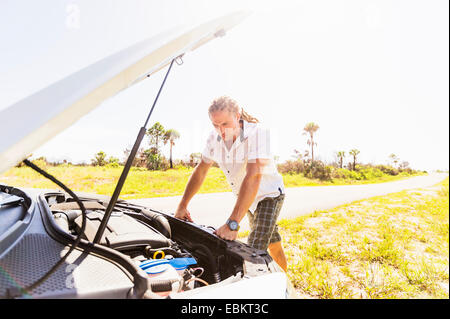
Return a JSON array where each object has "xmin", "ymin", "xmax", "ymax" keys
[{"xmin": 0, "ymin": 12, "xmax": 292, "ymax": 298}]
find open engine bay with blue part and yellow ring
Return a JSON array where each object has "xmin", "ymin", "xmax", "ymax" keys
[{"xmin": 44, "ymin": 193, "xmax": 271, "ymax": 297}]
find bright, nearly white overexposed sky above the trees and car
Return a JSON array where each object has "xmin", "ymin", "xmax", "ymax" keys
[{"xmin": 0, "ymin": 0, "xmax": 449, "ymax": 170}]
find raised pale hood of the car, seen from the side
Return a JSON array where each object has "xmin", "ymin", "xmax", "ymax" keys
[{"xmin": 0, "ymin": 11, "xmax": 249, "ymax": 173}]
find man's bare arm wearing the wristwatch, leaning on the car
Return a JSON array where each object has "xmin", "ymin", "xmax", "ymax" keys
[{"xmin": 216, "ymin": 159, "xmax": 269, "ymax": 240}]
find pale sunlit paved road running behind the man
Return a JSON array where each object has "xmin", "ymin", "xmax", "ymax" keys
[{"xmin": 130, "ymin": 173, "xmax": 448, "ymax": 230}]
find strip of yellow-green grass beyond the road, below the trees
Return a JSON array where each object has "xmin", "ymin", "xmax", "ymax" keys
[{"xmin": 0, "ymin": 162, "xmax": 426, "ymax": 199}]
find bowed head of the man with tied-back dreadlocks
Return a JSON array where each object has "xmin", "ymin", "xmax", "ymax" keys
[{"xmin": 208, "ymin": 96, "xmax": 258, "ymax": 141}]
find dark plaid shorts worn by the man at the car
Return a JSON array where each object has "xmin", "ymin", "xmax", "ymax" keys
[{"xmin": 247, "ymin": 194, "xmax": 284, "ymax": 250}]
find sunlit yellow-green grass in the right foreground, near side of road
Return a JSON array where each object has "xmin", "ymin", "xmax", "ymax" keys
[{"xmin": 272, "ymin": 178, "xmax": 449, "ymax": 299}]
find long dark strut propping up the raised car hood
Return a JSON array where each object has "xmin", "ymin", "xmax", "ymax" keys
[{"xmin": 94, "ymin": 58, "xmax": 177, "ymax": 244}]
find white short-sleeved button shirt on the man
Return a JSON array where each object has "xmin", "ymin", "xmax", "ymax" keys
[{"xmin": 202, "ymin": 121, "xmax": 284, "ymax": 213}]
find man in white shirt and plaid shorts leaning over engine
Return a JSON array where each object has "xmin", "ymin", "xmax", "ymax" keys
[{"xmin": 175, "ymin": 96, "xmax": 287, "ymax": 271}]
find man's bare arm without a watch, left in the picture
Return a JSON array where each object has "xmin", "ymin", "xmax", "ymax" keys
[{"xmin": 175, "ymin": 158, "xmax": 212, "ymax": 221}]
